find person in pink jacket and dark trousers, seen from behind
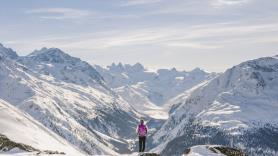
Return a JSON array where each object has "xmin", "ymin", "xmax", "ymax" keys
[{"xmin": 136, "ymin": 119, "xmax": 148, "ymax": 153}]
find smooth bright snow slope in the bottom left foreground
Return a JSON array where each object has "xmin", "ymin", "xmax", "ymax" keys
[{"xmin": 0, "ymin": 99, "xmax": 83, "ymax": 155}]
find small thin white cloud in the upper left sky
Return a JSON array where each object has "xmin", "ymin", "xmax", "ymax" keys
[{"xmin": 26, "ymin": 8, "xmax": 94, "ymax": 20}]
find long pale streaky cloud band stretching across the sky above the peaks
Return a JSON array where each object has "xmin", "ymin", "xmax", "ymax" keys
[{"xmin": 4, "ymin": 23, "xmax": 278, "ymax": 51}]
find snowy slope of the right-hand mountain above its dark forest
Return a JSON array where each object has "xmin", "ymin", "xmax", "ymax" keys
[{"xmin": 153, "ymin": 57, "xmax": 278, "ymax": 155}]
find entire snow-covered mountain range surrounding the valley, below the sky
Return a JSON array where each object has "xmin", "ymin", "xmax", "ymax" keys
[{"xmin": 0, "ymin": 44, "xmax": 278, "ymax": 155}]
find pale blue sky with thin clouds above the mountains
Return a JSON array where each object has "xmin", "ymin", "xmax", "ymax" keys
[{"xmin": 0, "ymin": 0, "xmax": 278, "ymax": 72}]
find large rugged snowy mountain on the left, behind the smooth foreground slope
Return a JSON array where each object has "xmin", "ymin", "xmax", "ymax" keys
[{"xmin": 0, "ymin": 44, "xmax": 138, "ymax": 155}]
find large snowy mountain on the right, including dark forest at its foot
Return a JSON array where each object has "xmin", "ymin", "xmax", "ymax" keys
[{"xmin": 153, "ymin": 56, "xmax": 278, "ymax": 155}]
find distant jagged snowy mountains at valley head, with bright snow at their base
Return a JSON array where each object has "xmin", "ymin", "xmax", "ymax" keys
[{"xmin": 95, "ymin": 63, "xmax": 215, "ymax": 119}]
